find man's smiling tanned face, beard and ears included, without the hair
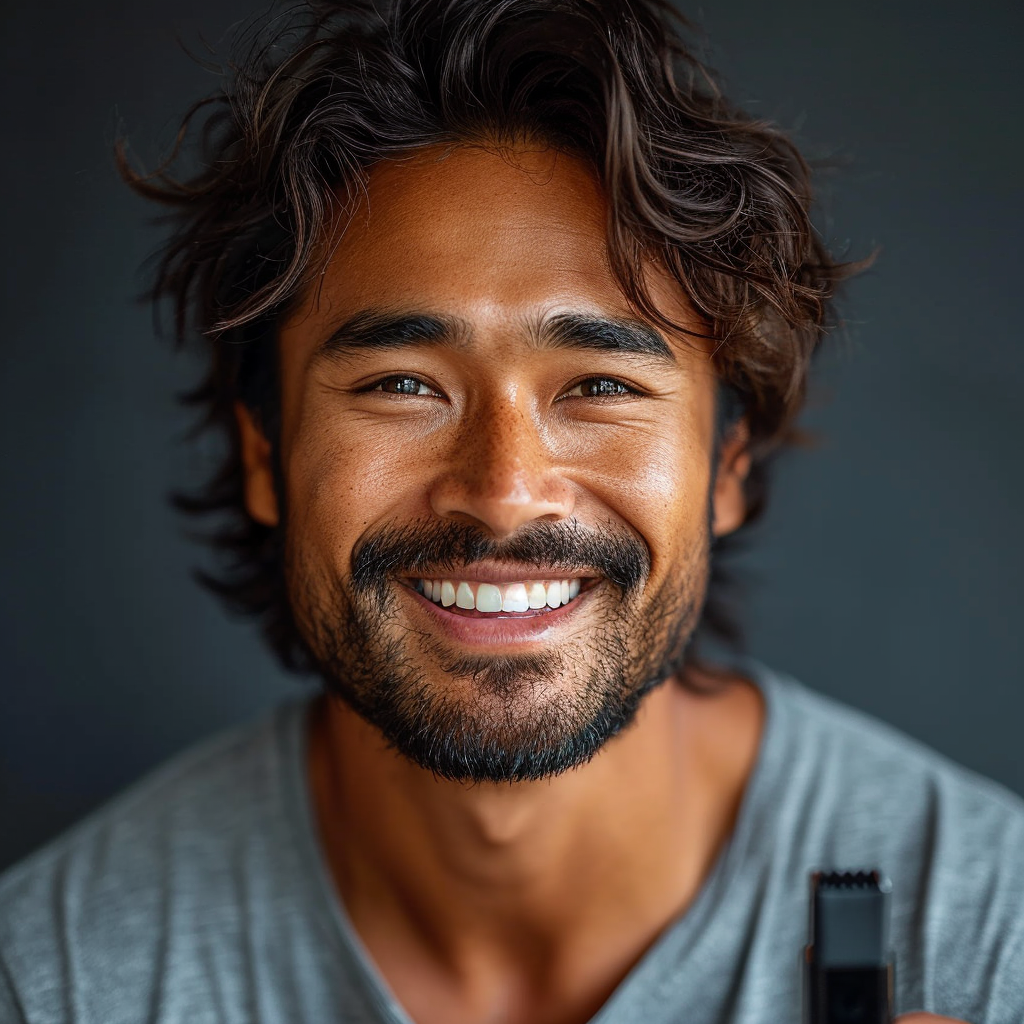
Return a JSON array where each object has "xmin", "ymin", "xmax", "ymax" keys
[{"xmin": 242, "ymin": 146, "xmax": 741, "ymax": 780}]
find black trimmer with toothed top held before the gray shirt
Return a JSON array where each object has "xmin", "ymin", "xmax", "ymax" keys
[{"xmin": 804, "ymin": 871, "xmax": 894, "ymax": 1024}]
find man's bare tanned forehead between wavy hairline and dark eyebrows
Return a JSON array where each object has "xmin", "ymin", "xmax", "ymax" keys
[{"xmin": 296, "ymin": 145, "xmax": 693, "ymax": 337}]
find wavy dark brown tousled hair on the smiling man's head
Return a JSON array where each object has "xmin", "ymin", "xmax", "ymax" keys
[{"xmin": 118, "ymin": 0, "xmax": 850, "ymax": 671}]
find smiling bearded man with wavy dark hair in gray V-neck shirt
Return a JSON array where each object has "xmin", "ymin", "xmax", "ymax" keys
[{"xmin": 0, "ymin": 0, "xmax": 1024, "ymax": 1024}]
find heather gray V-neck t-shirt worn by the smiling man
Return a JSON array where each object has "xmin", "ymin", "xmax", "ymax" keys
[{"xmin": 0, "ymin": 669, "xmax": 1024, "ymax": 1024}]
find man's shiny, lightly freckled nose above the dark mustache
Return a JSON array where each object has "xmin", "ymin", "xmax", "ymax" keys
[{"xmin": 430, "ymin": 395, "xmax": 574, "ymax": 540}]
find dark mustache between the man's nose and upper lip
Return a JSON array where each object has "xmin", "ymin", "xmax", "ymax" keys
[{"xmin": 351, "ymin": 520, "xmax": 650, "ymax": 594}]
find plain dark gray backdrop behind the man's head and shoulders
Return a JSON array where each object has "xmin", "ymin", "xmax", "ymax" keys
[{"xmin": 0, "ymin": 0, "xmax": 1024, "ymax": 865}]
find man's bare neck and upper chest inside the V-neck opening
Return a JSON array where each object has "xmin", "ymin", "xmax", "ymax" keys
[{"xmin": 309, "ymin": 680, "xmax": 762, "ymax": 1019}]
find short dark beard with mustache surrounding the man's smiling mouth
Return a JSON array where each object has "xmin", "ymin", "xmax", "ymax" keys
[{"xmin": 288, "ymin": 522, "xmax": 708, "ymax": 782}]
